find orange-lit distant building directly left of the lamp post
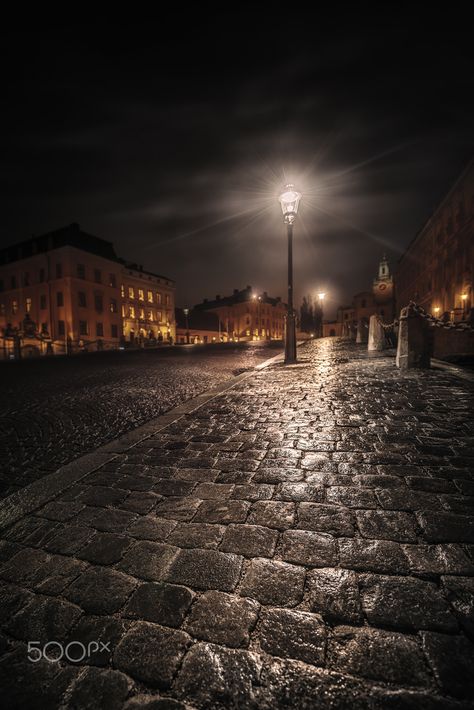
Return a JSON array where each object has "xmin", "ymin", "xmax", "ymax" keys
[{"xmin": 194, "ymin": 286, "xmax": 286, "ymax": 340}]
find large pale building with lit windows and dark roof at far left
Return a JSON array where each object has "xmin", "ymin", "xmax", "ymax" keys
[{"xmin": 0, "ymin": 223, "xmax": 175, "ymax": 356}]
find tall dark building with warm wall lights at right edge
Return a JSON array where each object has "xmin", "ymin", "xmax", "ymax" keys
[{"xmin": 396, "ymin": 161, "xmax": 474, "ymax": 321}]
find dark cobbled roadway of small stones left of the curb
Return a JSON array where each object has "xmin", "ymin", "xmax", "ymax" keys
[{"xmin": 0, "ymin": 343, "xmax": 279, "ymax": 498}]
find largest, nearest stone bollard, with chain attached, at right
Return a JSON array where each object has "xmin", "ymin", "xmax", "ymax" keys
[{"xmin": 395, "ymin": 307, "xmax": 433, "ymax": 370}]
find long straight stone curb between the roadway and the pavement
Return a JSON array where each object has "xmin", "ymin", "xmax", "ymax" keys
[{"xmin": 0, "ymin": 353, "xmax": 283, "ymax": 531}]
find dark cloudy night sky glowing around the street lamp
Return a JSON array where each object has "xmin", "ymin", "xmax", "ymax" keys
[{"xmin": 0, "ymin": 16, "xmax": 474, "ymax": 313}]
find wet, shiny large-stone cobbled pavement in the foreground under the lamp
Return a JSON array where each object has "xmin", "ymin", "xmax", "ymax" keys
[{"xmin": 0, "ymin": 339, "xmax": 474, "ymax": 710}]
